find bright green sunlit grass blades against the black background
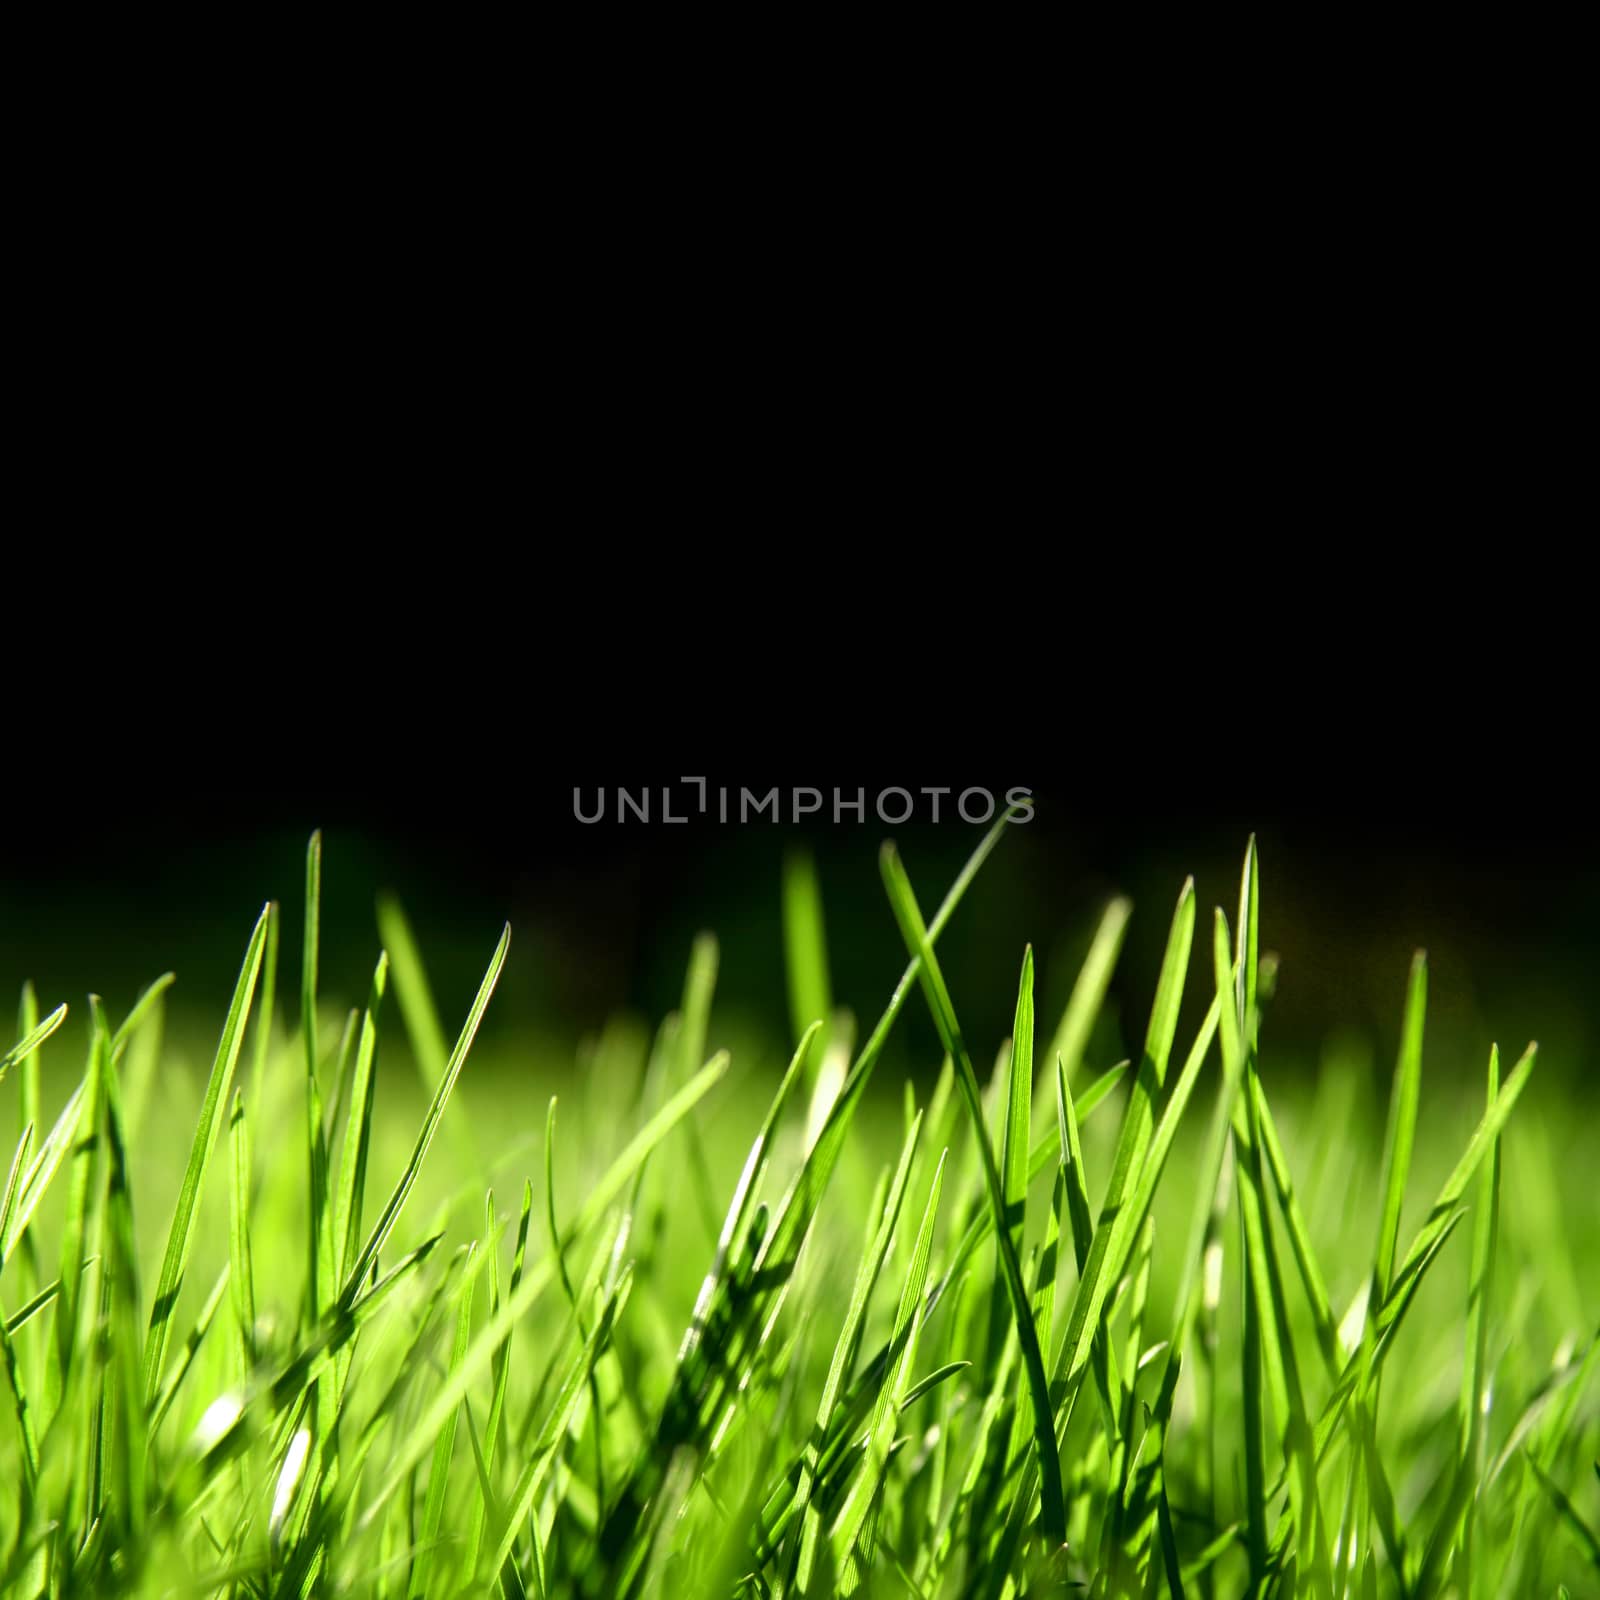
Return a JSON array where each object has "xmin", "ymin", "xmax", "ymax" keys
[{"xmin": 0, "ymin": 822, "xmax": 1600, "ymax": 1600}]
